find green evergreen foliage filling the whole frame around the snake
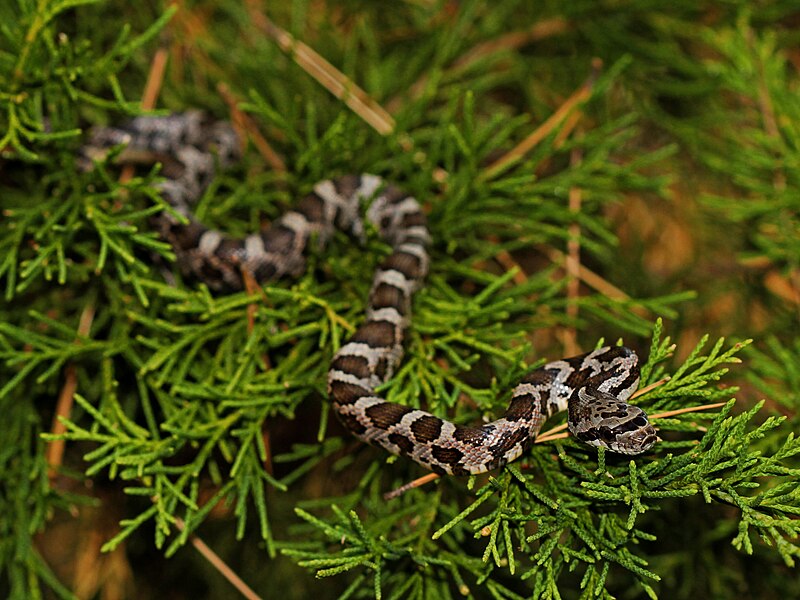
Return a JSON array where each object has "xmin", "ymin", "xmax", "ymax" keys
[{"xmin": 0, "ymin": 0, "xmax": 800, "ymax": 598}]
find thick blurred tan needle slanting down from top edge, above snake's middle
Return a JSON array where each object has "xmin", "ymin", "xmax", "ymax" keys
[{"xmin": 247, "ymin": 0, "xmax": 395, "ymax": 135}]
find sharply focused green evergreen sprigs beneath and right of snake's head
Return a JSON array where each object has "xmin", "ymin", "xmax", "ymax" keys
[{"xmin": 283, "ymin": 326, "xmax": 800, "ymax": 598}]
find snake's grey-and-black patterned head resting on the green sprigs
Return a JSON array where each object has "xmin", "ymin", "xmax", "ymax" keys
[{"xmin": 568, "ymin": 388, "xmax": 658, "ymax": 454}]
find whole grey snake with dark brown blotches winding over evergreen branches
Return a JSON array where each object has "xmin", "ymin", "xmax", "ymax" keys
[{"xmin": 79, "ymin": 111, "xmax": 658, "ymax": 475}]
